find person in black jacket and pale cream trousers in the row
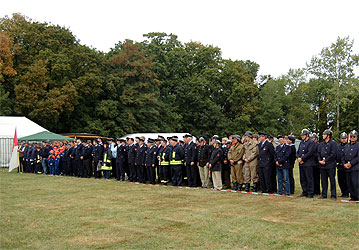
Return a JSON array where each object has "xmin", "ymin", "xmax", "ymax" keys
[{"xmin": 208, "ymin": 140, "xmax": 223, "ymax": 190}]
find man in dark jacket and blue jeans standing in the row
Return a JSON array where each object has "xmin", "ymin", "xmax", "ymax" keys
[{"xmin": 274, "ymin": 135, "xmax": 291, "ymax": 196}]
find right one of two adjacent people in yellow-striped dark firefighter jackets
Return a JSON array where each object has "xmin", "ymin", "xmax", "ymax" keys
[{"xmin": 169, "ymin": 137, "xmax": 184, "ymax": 186}]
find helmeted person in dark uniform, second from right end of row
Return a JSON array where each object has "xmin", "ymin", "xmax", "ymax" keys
[{"xmin": 337, "ymin": 132, "xmax": 349, "ymax": 198}]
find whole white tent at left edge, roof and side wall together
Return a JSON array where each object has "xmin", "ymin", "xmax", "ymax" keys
[{"xmin": 0, "ymin": 116, "xmax": 47, "ymax": 168}]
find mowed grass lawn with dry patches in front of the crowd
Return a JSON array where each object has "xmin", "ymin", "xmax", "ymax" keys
[{"xmin": 0, "ymin": 168, "xmax": 359, "ymax": 249}]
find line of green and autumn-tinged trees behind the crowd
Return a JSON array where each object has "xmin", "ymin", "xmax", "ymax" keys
[{"xmin": 0, "ymin": 14, "xmax": 359, "ymax": 139}]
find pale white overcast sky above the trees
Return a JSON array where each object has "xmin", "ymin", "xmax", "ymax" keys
[{"xmin": 0, "ymin": 0, "xmax": 359, "ymax": 76}]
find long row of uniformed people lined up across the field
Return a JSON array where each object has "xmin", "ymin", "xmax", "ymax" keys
[{"xmin": 15, "ymin": 129, "xmax": 359, "ymax": 201}]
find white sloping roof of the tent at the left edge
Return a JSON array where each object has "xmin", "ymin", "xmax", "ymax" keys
[{"xmin": 0, "ymin": 116, "xmax": 47, "ymax": 138}]
